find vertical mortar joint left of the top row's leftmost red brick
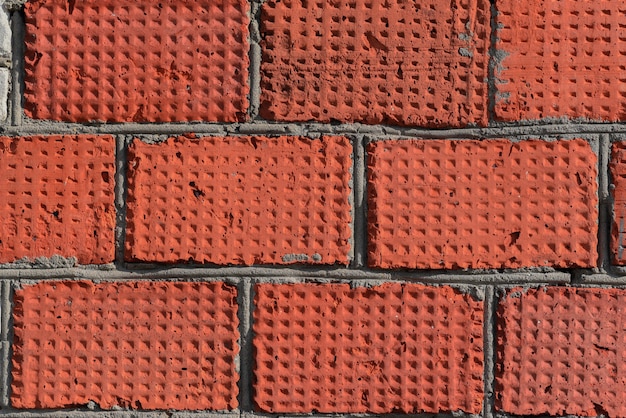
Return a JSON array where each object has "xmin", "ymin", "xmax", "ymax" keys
[{"xmin": 9, "ymin": 9, "xmax": 26, "ymax": 126}]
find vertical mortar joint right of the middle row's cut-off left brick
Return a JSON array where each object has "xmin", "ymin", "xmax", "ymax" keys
[{"xmin": 115, "ymin": 135, "xmax": 128, "ymax": 265}]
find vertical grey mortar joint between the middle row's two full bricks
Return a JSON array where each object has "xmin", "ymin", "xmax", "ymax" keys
[{"xmin": 352, "ymin": 136, "xmax": 367, "ymax": 268}]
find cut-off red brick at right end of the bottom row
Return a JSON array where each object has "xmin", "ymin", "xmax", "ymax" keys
[{"xmin": 496, "ymin": 288, "xmax": 626, "ymax": 417}]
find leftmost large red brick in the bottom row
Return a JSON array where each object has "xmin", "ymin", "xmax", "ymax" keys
[{"xmin": 11, "ymin": 281, "xmax": 239, "ymax": 410}]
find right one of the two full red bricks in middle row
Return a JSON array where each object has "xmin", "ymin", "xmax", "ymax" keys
[{"xmin": 368, "ymin": 140, "xmax": 598, "ymax": 269}]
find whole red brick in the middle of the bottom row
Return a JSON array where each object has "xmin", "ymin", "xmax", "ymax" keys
[{"xmin": 254, "ymin": 284, "xmax": 483, "ymax": 414}]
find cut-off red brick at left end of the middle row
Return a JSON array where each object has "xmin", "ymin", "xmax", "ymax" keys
[{"xmin": 0, "ymin": 135, "xmax": 115, "ymax": 264}]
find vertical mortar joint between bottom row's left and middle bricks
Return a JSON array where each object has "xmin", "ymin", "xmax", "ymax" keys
[{"xmin": 237, "ymin": 277, "xmax": 254, "ymax": 412}]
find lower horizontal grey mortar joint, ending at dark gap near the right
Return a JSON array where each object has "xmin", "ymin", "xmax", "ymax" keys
[{"xmin": 0, "ymin": 267, "xmax": 571, "ymax": 285}]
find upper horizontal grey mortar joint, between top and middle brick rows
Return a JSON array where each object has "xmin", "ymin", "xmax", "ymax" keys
[{"xmin": 0, "ymin": 121, "xmax": 626, "ymax": 139}]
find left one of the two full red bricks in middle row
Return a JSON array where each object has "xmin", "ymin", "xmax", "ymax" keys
[{"xmin": 126, "ymin": 137, "xmax": 352, "ymax": 265}]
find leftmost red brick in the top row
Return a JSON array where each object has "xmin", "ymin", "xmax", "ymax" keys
[{"xmin": 24, "ymin": 0, "xmax": 249, "ymax": 122}]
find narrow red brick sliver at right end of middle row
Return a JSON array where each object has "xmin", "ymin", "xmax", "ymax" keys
[{"xmin": 611, "ymin": 142, "xmax": 626, "ymax": 265}]
